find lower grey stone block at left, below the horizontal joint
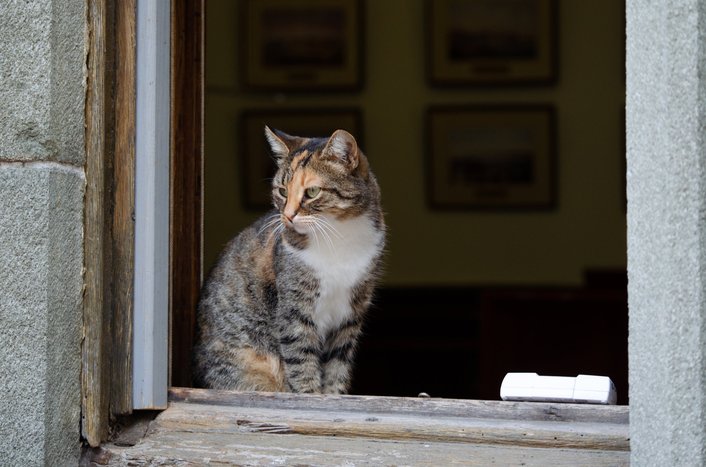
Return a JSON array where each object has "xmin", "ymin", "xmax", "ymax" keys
[{"xmin": 0, "ymin": 163, "xmax": 84, "ymax": 465}]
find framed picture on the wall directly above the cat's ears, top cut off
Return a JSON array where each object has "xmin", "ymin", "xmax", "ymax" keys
[{"xmin": 241, "ymin": 0, "xmax": 364, "ymax": 91}]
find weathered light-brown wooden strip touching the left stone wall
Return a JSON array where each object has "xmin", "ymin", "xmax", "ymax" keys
[{"xmin": 81, "ymin": 0, "xmax": 113, "ymax": 446}]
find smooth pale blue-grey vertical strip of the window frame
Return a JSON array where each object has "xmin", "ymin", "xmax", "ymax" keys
[{"xmin": 132, "ymin": 0, "xmax": 172, "ymax": 410}]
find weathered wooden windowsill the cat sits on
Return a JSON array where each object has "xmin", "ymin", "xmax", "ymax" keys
[{"xmin": 85, "ymin": 388, "xmax": 630, "ymax": 466}]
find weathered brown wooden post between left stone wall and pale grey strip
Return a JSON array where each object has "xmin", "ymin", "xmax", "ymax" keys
[{"xmin": 81, "ymin": 0, "xmax": 135, "ymax": 446}]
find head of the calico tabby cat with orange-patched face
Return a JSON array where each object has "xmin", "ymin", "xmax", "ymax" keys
[{"xmin": 265, "ymin": 127, "xmax": 380, "ymax": 234}]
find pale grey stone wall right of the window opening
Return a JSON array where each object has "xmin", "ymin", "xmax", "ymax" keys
[{"xmin": 627, "ymin": 0, "xmax": 706, "ymax": 466}]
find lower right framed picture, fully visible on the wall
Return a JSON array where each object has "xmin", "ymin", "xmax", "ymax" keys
[{"xmin": 427, "ymin": 106, "xmax": 556, "ymax": 209}]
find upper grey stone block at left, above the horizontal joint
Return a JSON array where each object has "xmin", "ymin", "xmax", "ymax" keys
[{"xmin": 0, "ymin": 0, "xmax": 86, "ymax": 165}]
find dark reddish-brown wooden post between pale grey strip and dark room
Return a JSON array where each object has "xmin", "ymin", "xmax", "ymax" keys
[{"xmin": 170, "ymin": 0, "xmax": 205, "ymax": 386}]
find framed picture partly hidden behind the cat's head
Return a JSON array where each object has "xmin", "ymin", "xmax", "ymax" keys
[{"xmin": 239, "ymin": 109, "xmax": 364, "ymax": 210}]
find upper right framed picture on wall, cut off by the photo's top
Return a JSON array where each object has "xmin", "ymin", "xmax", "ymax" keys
[{"xmin": 427, "ymin": 0, "xmax": 557, "ymax": 85}]
